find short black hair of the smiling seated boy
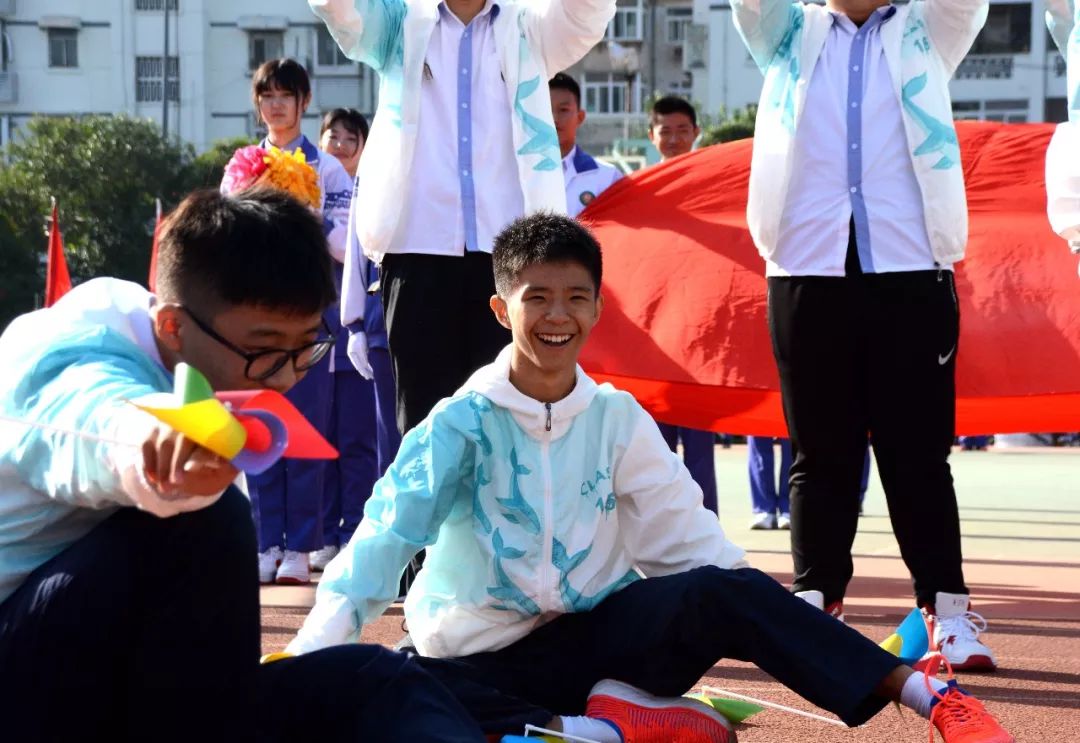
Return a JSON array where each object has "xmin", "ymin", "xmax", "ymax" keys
[{"xmin": 491, "ymin": 212, "xmax": 604, "ymax": 298}]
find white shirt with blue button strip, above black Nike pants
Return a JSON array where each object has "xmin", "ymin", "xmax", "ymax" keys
[{"xmin": 766, "ymin": 5, "xmax": 949, "ymax": 276}]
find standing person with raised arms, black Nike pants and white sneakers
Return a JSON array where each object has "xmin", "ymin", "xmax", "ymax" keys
[{"xmin": 732, "ymin": 0, "xmax": 997, "ymax": 671}]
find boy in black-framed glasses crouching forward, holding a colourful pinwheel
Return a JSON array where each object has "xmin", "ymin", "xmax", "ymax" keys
[{"xmin": 0, "ymin": 191, "xmax": 483, "ymax": 743}]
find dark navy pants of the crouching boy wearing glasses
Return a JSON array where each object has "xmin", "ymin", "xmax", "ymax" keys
[{"xmin": 0, "ymin": 488, "xmax": 484, "ymax": 743}]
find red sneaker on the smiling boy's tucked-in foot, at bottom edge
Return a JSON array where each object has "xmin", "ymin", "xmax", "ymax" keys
[{"xmin": 585, "ymin": 679, "xmax": 735, "ymax": 743}]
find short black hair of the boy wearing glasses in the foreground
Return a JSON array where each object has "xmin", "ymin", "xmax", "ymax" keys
[{"xmin": 157, "ymin": 188, "xmax": 337, "ymax": 316}]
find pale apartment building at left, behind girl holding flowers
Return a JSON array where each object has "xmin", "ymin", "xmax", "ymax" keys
[{"xmin": 0, "ymin": 0, "xmax": 377, "ymax": 149}]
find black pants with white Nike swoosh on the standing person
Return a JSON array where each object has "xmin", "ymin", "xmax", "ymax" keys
[{"xmin": 769, "ymin": 237, "xmax": 968, "ymax": 606}]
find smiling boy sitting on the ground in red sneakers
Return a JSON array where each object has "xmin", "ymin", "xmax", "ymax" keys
[{"xmin": 288, "ymin": 214, "xmax": 1013, "ymax": 743}]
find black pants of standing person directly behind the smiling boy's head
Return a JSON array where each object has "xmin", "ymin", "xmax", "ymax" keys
[{"xmin": 379, "ymin": 253, "xmax": 510, "ymax": 434}]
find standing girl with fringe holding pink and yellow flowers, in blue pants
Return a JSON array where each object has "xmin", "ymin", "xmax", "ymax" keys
[{"xmin": 232, "ymin": 59, "xmax": 352, "ymax": 583}]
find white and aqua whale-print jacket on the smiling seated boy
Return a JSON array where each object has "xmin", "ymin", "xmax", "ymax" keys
[{"xmin": 288, "ymin": 348, "xmax": 744, "ymax": 657}]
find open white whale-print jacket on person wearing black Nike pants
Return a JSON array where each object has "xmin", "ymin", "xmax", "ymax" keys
[{"xmin": 731, "ymin": 0, "xmax": 989, "ymax": 265}]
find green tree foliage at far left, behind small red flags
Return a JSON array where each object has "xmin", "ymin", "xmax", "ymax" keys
[{"xmin": 0, "ymin": 117, "xmax": 248, "ymax": 328}]
